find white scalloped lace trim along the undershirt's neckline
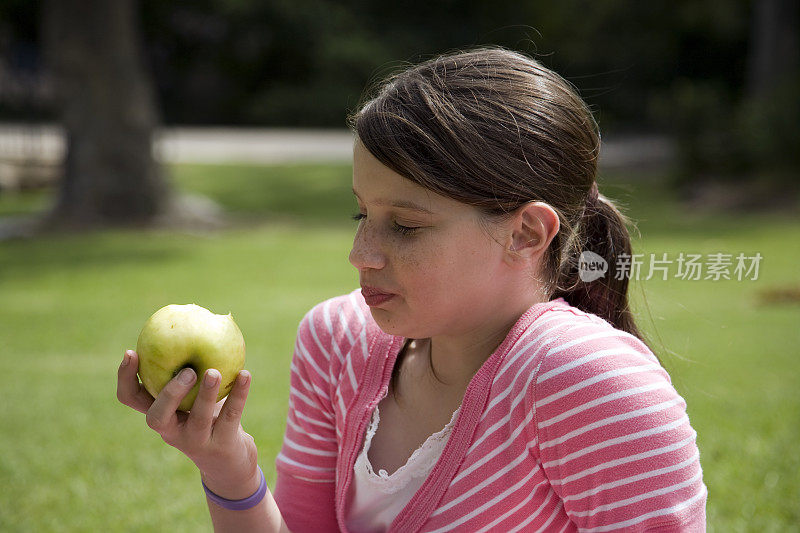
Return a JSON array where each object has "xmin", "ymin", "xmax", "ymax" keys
[{"xmin": 356, "ymin": 405, "xmax": 461, "ymax": 494}]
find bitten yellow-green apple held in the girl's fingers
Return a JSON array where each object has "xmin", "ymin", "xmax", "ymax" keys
[{"xmin": 136, "ymin": 304, "xmax": 244, "ymax": 411}]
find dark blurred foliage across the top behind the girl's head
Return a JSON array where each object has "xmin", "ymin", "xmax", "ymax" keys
[{"xmin": 0, "ymin": 0, "xmax": 800, "ymax": 187}]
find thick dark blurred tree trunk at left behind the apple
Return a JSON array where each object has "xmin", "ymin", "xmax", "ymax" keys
[{"xmin": 42, "ymin": 0, "xmax": 171, "ymax": 227}]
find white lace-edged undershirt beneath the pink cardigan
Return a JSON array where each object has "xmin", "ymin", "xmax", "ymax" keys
[{"xmin": 346, "ymin": 405, "xmax": 461, "ymax": 533}]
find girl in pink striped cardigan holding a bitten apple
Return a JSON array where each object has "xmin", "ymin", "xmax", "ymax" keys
[{"xmin": 118, "ymin": 48, "xmax": 707, "ymax": 532}]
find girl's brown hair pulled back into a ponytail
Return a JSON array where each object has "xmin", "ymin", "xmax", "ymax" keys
[{"xmin": 348, "ymin": 47, "xmax": 644, "ymax": 386}]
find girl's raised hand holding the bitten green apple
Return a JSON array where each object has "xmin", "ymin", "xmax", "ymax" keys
[{"xmin": 117, "ymin": 350, "xmax": 261, "ymax": 500}]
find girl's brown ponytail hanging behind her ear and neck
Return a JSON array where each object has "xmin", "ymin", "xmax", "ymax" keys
[{"xmin": 552, "ymin": 182, "xmax": 645, "ymax": 350}]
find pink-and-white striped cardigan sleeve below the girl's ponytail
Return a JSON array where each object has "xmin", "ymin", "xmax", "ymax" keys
[{"xmin": 530, "ymin": 308, "xmax": 705, "ymax": 530}]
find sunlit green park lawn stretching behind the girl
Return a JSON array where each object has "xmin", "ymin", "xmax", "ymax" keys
[{"xmin": 0, "ymin": 165, "xmax": 800, "ymax": 532}]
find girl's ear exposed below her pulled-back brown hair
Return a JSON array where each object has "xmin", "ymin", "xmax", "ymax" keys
[{"xmin": 506, "ymin": 202, "xmax": 561, "ymax": 266}]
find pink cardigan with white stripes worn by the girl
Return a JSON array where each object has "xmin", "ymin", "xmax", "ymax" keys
[{"xmin": 274, "ymin": 290, "xmax": 707, "ymax": 533}]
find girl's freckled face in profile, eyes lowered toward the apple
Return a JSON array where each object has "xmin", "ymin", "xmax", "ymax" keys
[{"xmin": 350, "ymin": 140, "xmax": 504, "ymax": 338}]
